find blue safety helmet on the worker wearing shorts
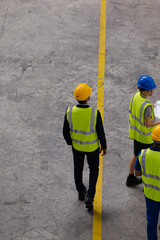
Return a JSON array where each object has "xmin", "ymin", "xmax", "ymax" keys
[{"xmin": 137, "ymin": 75, "xmax": 156, "ymax": 90}]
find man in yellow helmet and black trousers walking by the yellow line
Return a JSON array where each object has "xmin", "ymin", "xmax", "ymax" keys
[{"xmin": 63, "ymin": 83, "xmax": 107, "ymax": 210}]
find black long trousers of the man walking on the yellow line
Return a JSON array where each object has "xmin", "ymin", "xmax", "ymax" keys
[{"xmin": 72, "ymin": 147, "xmax": 99, "ymax": 198}]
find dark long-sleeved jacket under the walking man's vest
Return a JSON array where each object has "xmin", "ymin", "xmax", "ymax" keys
[{"xmin": 63, "ymin": 104, "xmax": 107, "ymax": 150}]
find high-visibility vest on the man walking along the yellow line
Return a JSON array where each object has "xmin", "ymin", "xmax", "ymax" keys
[{"xmin": 67, "ymin": 106, "xmax": 99, "ymax": 152}]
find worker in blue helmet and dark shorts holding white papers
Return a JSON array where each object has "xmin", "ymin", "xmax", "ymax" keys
[{"xmin": 126, "ymin": 75, "xmax": 160, "ymax": 187}]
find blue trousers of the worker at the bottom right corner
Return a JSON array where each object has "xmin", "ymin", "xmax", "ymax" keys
[{"xmin": 145, "ymin": 197, "xmax": 160, "ymax": 240}]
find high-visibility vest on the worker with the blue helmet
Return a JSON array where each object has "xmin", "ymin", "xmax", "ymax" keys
[{"xmin": 129, "ymin": 92, "xmax": 155, "ymax": 144}]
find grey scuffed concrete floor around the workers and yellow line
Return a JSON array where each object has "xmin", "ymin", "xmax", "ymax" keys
[{"xmin": 0, "ymin": 0, "xmax": 160, "ymax": 240}]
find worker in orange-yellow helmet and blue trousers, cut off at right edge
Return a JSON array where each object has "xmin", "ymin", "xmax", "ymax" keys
[{"xmin": 135, "ymin": 125, "xmax": 160, "ymax": 240}]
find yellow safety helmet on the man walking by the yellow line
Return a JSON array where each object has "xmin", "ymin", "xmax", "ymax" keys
[{"xmin": 74, "ymin": 83, "xmax": 92, "ymax": 101}]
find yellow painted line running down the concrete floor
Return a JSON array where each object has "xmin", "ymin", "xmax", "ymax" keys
[{"xmin": 92, "ymin": 0, "xmax": 107, "ymax": 240}]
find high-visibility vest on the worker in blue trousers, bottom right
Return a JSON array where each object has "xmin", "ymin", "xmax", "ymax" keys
[{"xmin": 139, "ymin": 148, "xmax": 160, "ymax": 202}]
